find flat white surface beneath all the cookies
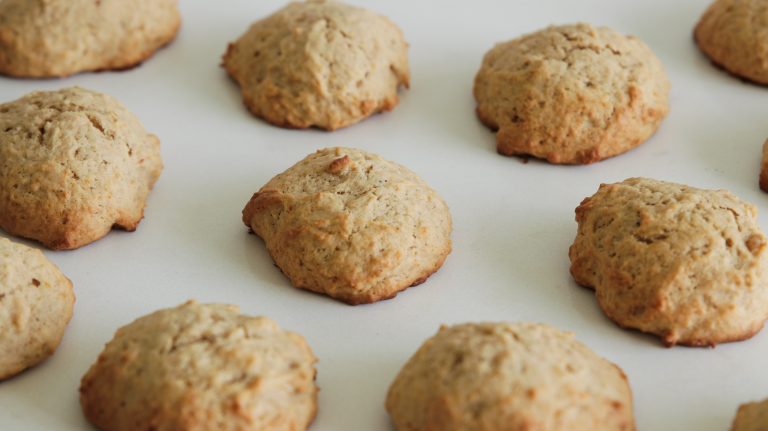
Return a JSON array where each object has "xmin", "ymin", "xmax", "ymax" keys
[{"xmin": 0, "ymin": 0, "xmax": 768, "ymax": 431}]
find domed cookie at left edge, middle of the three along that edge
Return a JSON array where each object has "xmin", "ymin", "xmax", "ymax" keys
[{"xmin": 0, "ymin": 87, "xmax": 163, "ymax": 249}]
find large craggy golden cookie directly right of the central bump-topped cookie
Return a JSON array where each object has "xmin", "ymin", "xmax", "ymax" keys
[{"xmin": 569, "ymin": 178, "xmax": 768, "ymax": 346}]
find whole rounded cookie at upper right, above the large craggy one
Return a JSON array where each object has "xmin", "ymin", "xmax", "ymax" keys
[{"xmin": 474, "ymin": 24, "xmax": 669, "ymax": 164}]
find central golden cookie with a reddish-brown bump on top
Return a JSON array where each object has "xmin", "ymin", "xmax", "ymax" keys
[{"xmin": 243, "ymin": 148, "xmax": 451, "ymax": 304}]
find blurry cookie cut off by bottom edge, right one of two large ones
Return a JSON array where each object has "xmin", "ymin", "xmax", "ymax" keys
[{"xmin": 386, "ymin": 323, "xmax": 635, "ymax": 431}]
